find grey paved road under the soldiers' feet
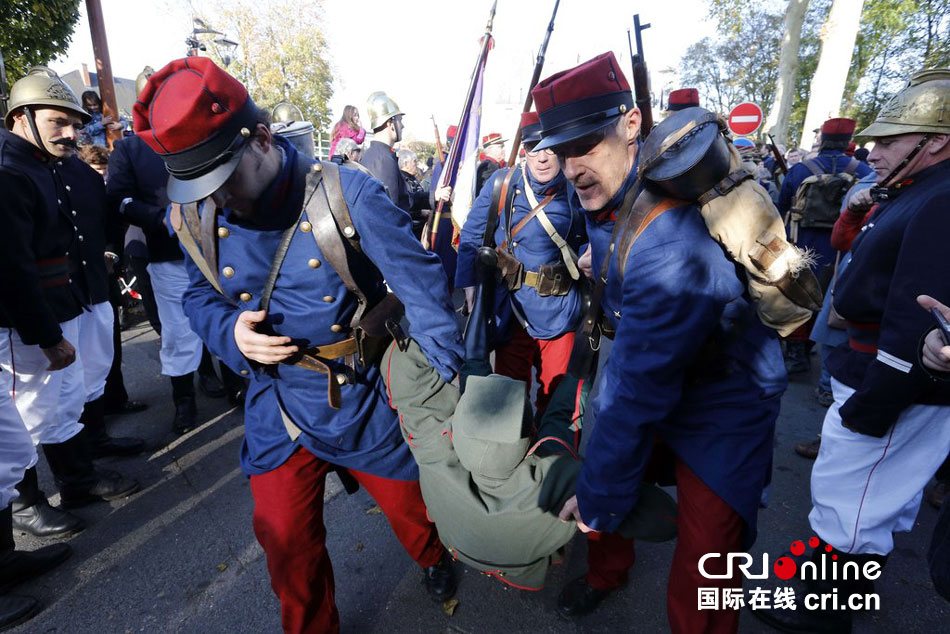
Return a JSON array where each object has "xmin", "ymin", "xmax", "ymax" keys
[{"xmin": 13, "ymin": 327, "xmax": 950, "ymax": 634}]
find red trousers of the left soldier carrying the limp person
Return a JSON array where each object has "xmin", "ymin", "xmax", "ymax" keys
[{"xmin": 251, "ymin": 447, "xmax": 445, "ymax": 634}]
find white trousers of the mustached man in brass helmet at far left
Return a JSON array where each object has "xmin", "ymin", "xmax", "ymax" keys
[{"xmin": 0, "ymin": 317, "xmax": 86, "ymax": 445}]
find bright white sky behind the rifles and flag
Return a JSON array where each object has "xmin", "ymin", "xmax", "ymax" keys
[{"xmin": 52, "ymin": 0, "xmax": 715, "ymax": 141}]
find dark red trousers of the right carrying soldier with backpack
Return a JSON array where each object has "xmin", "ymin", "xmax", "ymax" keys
[{"xmin": 587, "ymin": 460, "xmax": 743, "ymax": 634}]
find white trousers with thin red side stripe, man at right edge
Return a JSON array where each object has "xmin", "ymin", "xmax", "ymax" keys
[{"xmin": 808, "ymin": 378, "xmax": 950, "ymax": 555}]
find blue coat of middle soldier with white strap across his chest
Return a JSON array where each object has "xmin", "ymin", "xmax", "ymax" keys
[{"xmin": 455, "ymin": 168, "xmax": 587, "ymax": 339}]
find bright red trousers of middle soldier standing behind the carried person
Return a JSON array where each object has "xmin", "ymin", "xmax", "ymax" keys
[{"xmin": 495, "ymin": 322, "xmax": 574, "ymax": 416}]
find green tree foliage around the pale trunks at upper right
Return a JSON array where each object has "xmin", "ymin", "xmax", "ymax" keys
[{"xmin": 692, "ymin": 0, "xmax": 950, "ymax": 146}]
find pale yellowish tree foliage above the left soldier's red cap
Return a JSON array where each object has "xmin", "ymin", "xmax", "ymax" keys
[{"xmin": 197, "ymin": 0, "xmax": 333, "ymax": 130}]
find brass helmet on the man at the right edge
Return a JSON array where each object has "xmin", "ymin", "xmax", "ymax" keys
[{"xmin": 858, "ymin": 68, "xmax": 950, "ymax": 137}]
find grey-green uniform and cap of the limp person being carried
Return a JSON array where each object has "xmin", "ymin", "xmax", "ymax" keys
[{"xmin": 383, "ymin": 341, "xmax": 676, "ymax": 590}]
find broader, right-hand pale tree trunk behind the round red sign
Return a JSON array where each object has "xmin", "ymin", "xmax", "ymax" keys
[{"xmin": 801, "ymin": 0, "xmax": 864, "ymax": 149}]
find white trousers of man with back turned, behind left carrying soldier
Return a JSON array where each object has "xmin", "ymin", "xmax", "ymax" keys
[{"xmin": 148, "ymin": 261, "xmax": 201, "ymax": 376}]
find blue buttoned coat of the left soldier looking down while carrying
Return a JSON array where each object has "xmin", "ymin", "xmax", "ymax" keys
[{"xmin": 184, "ymin": 137, "xmax": 462, "ymax": 480}]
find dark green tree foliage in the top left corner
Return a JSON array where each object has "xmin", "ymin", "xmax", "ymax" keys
[{"xmin": 0, "ymin": 0, "xmax": 79, "ymax": 84}]
